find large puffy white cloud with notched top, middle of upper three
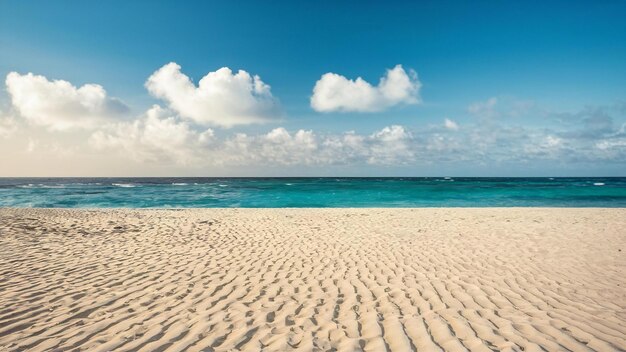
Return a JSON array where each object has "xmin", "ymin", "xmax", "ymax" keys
[{"xmin": 145, "ymin": 62, "xmax": 278, "ymax": 128}]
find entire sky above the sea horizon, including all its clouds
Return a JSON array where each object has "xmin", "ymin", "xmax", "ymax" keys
[{"xmin": 0, "ymin": 0, "xmax": 626, "ymax": 177}]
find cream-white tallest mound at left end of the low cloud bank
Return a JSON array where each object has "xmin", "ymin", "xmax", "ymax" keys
[{"xmin": 89, "ymin": 105, "xmax": 213, "ymax": 165}]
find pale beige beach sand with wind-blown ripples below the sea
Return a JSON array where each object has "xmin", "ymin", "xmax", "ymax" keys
[{"xmin": 0, "ymin": 208, "xmax": 626, "ymax": 351}]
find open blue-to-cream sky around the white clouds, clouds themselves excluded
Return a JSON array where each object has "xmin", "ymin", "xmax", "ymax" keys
[{"xmin": 0, "ymin": 1, "xmax": 626, "ymax": 175}]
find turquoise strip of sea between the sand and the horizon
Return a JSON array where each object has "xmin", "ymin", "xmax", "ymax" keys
[{"xmin": 0, "ymin": 177, "xmax": 626, "ymax": 208}]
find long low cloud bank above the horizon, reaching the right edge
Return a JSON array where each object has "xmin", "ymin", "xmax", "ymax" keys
[{"xmin": 90, "ymin": 114, "xmax": 626, "ymax": 167}]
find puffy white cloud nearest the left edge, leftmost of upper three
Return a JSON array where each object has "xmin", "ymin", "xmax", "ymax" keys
[{"xmin": 6, "ymin": 72, "xmax": 128, "ymax": 131}]
